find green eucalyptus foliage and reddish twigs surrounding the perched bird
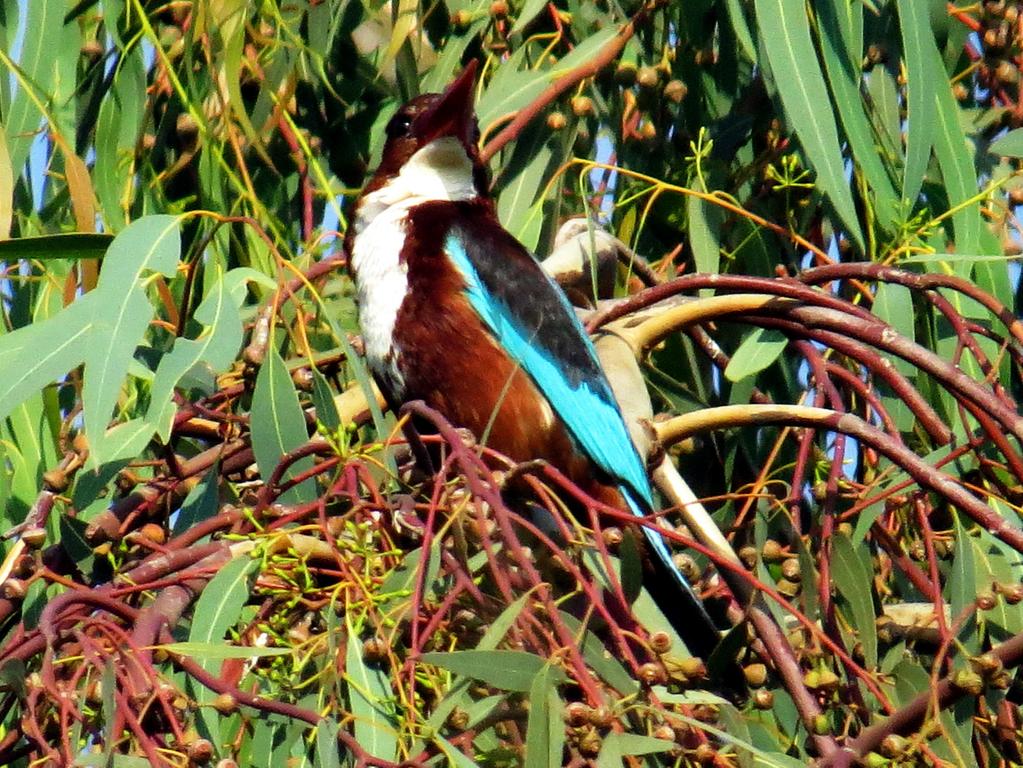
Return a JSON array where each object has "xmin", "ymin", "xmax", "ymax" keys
[{"xmin": 0, "ymin": 0, "xmax": 1023, "ymax": 767}]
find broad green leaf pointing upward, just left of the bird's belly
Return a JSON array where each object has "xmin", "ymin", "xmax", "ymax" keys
[{"xmin": 252, "ymin": 347, "xmax": 316, "ymax": 504}]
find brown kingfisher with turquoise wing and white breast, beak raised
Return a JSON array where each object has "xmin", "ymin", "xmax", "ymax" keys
[{"xmin": 344, "ymin": 60, "xmax": 720, "ymax": 658}]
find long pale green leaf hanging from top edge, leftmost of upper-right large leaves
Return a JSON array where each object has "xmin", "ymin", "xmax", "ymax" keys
[{"xmin": 754, "ymin": 0, "xmax": 863, "ymax": 251}]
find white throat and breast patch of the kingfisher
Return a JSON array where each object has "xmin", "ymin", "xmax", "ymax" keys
[{"xmin": 352, "ymin": 137, "xmax": 477, "ymax": 396}]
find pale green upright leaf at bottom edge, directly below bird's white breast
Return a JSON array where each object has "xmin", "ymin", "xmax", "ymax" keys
[{"xmin": 345, "ymin": 625, "xmax": 398, "ymax": 760}]
